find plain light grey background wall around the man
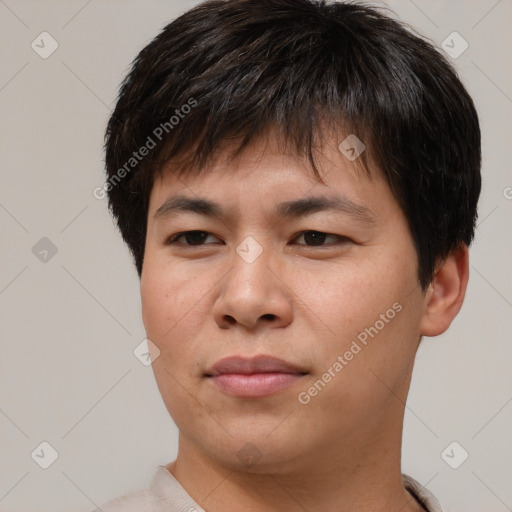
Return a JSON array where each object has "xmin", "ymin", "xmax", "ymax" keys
[{"xmin": 0, "ymin": 0, "xmax": 512, "ymax": 512}]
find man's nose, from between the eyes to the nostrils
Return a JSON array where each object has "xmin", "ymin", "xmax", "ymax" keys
[{"xmin": 213, "ymin": 244, "xmax": 293, "ymax": 330}]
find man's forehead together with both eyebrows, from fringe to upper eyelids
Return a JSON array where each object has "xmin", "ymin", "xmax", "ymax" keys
[{"xmin": 148, "ymin": 131, "xmax": 393, "ymax": 229}]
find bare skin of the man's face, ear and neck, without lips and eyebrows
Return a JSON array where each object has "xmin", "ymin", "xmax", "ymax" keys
[{"xmin": 141, "ymin": 132, "xmax": 468, "ymax": 512}]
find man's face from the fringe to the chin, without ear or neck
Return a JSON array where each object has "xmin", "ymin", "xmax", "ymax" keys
[{"xmin": 141, "ymin": 132, "xmax": 424, "ymax": 472}]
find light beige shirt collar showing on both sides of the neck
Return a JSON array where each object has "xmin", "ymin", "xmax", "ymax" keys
[{"xmin": 92, "ymin": 466, "xmax": 443, "ymax": 512}]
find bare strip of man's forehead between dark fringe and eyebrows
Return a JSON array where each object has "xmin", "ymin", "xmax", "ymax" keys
[{"xmin": 150, "ymin": 128, "xmax": 374, "ymax": 194}]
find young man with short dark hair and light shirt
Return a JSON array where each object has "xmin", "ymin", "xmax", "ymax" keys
[{"xmin": 95, "ymin": 0, "xmax": 480, "ymax": 512}]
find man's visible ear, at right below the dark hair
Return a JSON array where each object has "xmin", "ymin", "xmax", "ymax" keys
[{"xmin": 420, "ymin": 244, "xmax": 469, "ymax": 336}]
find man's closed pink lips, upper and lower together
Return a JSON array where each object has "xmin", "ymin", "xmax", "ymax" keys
[{"xmin": 205, "ymin": 355, "xmax": 308, "ymax": 398}]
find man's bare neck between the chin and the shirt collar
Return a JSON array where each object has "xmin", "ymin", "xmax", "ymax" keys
[{"xmin": 166, "ymin": 416, "xmax": 424, "ymax": 512}]
